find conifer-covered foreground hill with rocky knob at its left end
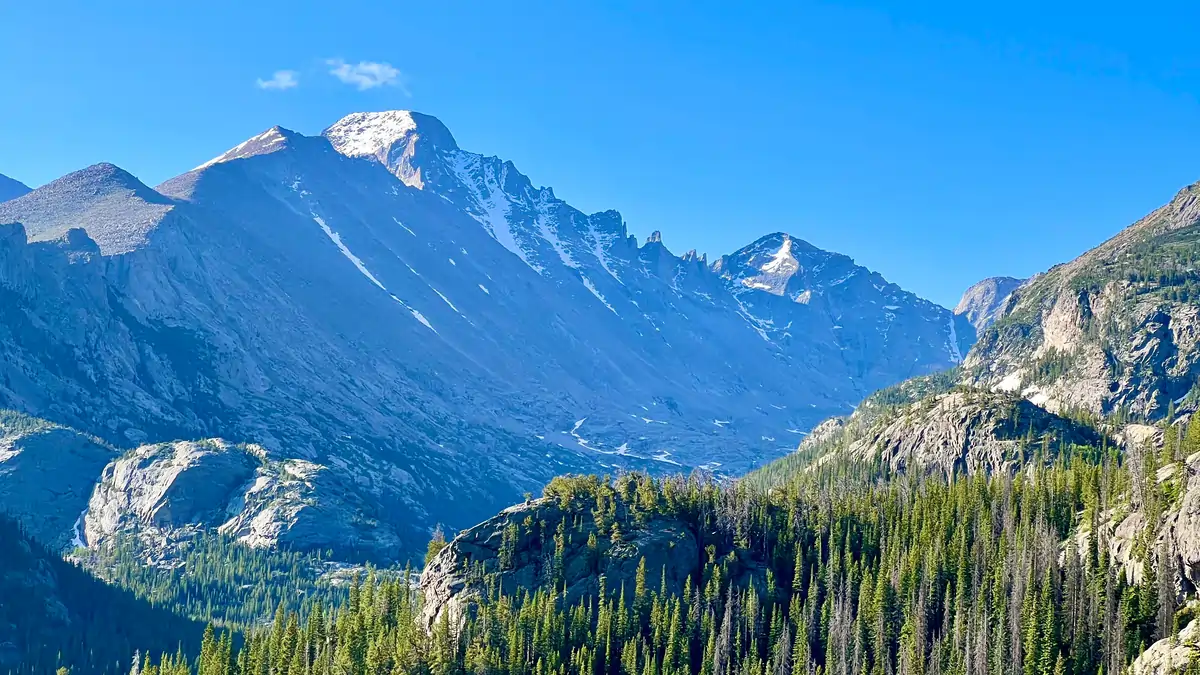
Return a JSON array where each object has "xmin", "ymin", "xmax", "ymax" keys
[{"xmin": 412, "ymin": 448, "xmax": 1200, "ymax": 675}]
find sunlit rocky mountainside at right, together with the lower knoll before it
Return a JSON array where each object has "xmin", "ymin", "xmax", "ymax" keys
[{"xmin": 751, "ymin": 178, "xmax": 1200, "ymax": 485}]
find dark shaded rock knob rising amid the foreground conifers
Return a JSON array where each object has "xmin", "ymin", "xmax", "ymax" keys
[{"xmin": 421, "ymin": 498, "xmax": 701, "ymax": 626}]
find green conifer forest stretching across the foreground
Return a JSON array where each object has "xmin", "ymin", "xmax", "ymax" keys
[{"xmin": 126, "ymin": 450, "xmax": 1189, "ymax": 675}]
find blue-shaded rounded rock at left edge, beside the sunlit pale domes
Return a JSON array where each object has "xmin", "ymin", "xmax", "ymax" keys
[{"xmin": 0, "ymin": 411, "xmax": 116, "ymax": 550}]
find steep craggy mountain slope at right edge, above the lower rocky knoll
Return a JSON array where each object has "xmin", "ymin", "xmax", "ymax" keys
[{"xmin": 964, "ymin": 184, "xmax": 1200, "ymax": 419}]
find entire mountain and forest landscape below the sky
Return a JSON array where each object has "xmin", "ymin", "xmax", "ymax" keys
[{"xmin": 0, "ymin": 110, "xmax": 1200, "ymax": 675}]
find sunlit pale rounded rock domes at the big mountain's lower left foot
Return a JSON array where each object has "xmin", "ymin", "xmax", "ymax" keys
[{"xmin": 83, "ymin": 440, "xmax": 401, "ymax": 561}]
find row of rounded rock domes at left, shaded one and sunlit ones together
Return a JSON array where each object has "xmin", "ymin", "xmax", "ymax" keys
[{"xmin": 0, "ymin": 411, "xmax": 406, "ymax": 562}]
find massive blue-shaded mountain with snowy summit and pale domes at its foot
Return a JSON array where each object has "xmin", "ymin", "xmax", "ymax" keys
[{"xmin": 0, "ymin": 112, "xmax": 974, "ymax": 561}]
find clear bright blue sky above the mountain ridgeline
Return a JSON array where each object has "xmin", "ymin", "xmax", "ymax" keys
[{"xmin": 0, "ymin": 0, "xmax": 1200, "ymax": 305}]
